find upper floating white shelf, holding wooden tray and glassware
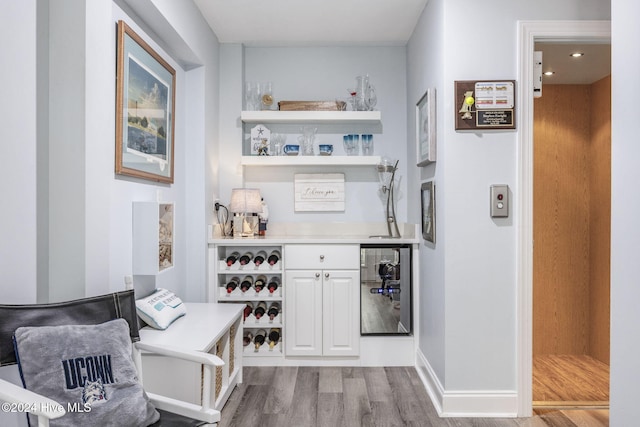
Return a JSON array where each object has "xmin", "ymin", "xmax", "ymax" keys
[{"xmin": 240, "ymin": 111, "xmax": 382, "ymax": 125}]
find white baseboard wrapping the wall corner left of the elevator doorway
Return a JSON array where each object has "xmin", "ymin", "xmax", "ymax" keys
[{"xmin": 416, "ymin": 349, "xmax": 518, "ymax": 418}]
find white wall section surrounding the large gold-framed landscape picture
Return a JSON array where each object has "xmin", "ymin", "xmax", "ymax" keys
[{"xmin": 108, "ymin": 0, "xmax": 218, "ymax": 301}]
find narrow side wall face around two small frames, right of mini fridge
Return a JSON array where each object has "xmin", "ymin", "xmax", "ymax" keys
[{"xmin": 407, "ymin": 1, "xmax": 447, "ymax": 383}]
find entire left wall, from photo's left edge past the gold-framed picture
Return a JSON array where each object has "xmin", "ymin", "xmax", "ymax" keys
[{"xmin": 0, "ymin": 0, "xmax": 219, "ymax": 308}]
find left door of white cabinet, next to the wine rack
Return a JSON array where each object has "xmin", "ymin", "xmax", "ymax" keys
[{"xmin": 284, "ymin": 270, "xmax": 322, "ymax": 356}]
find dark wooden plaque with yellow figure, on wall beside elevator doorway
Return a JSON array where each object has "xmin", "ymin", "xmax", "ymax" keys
[{"xmin": 455, "ymin": 80, "xmax": 516, "ymax": 130}]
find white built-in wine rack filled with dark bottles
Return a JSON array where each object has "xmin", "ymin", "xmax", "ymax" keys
[{"xmin": 212, "ymin": 244, "xmax": 284, "ymax": 357}]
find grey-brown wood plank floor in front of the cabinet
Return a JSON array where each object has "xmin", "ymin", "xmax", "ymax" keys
[{"xmin": 218, "ymin": 367, "xmax": 609, "ymax": 427}]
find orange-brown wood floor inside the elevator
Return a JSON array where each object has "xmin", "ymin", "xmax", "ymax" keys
[{"xmin": 533, "ymin": 354, "xmax": 609, "ymax": 408}]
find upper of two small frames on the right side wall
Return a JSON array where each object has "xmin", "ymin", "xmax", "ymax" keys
[{"xmin": 416, "ymin": 88, "xmax": 436, "ymax": 166}]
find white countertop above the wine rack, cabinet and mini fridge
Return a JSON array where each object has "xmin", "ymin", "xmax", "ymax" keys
[{"xmin": 208, "ymin": 222, "xmax": 420, "ymax": 246}]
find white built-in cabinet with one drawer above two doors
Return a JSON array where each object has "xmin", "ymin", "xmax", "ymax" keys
[{"xmin": 284, "ymin": 244, "xmax": 360, "ymax": 356}]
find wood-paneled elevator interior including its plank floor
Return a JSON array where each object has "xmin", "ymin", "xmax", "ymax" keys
[{"xmin": 533, "ymin": 76, "xmax": 611, "ymax": 408}]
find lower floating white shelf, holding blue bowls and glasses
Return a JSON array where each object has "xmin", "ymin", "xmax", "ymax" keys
[{"xmin": 240, "ymin": 155, "xmax": 381, "ymax": 166}]
